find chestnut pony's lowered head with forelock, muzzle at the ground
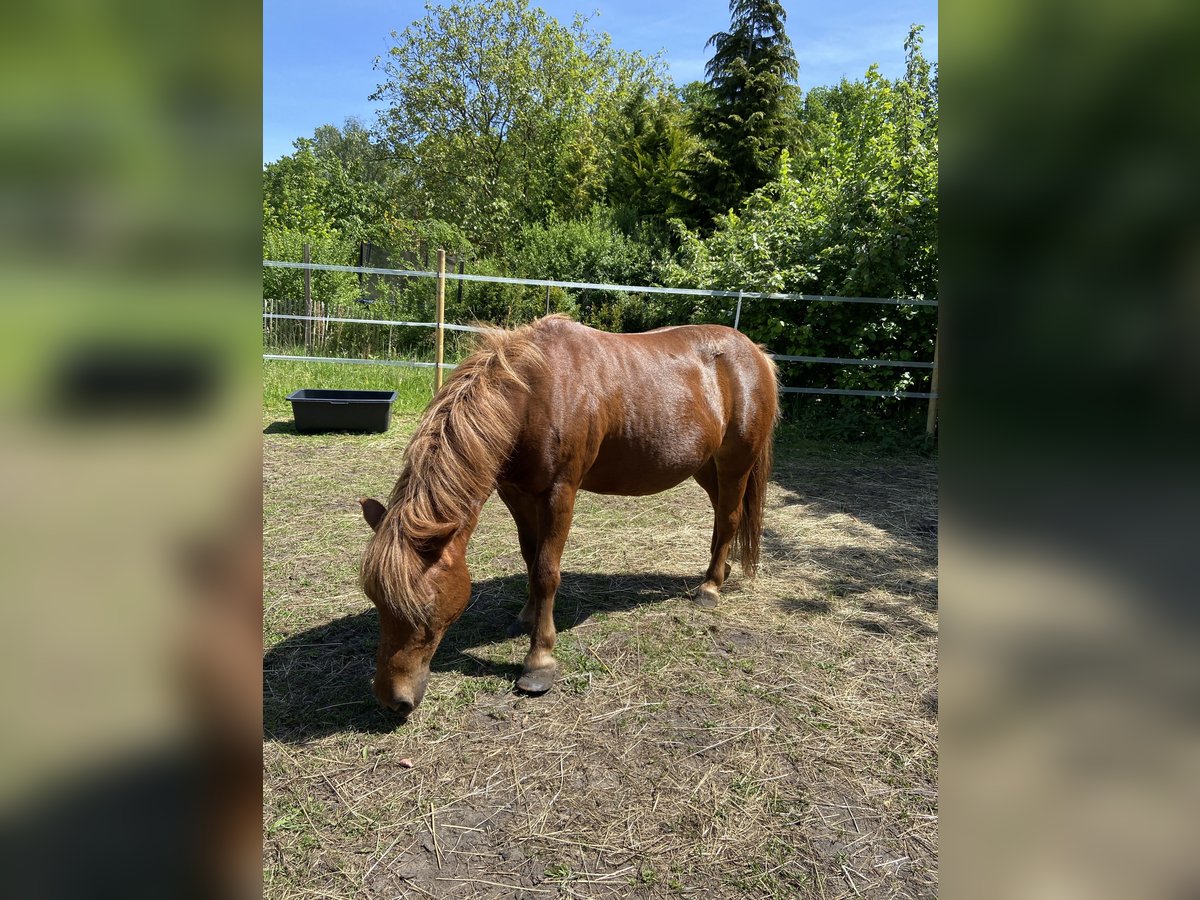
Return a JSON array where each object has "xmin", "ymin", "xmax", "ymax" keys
[{"xmin": 359, "ymin": 499, "xmax": 470, "ymax": 716}]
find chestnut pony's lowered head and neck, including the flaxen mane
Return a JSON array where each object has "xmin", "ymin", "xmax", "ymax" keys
[{"xmin": 360, "ymin": 325, "xmax": 545, "ymax": 715}]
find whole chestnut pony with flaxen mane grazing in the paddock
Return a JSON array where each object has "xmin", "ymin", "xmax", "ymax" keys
[{"xmin": 360, "ymin": 316, "xmax": 779, "ymax": 716}]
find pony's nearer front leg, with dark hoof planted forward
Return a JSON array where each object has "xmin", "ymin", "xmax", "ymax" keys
[{"xmin": 517, "ymin": 485, "xmax": 575, "ymax": 694}]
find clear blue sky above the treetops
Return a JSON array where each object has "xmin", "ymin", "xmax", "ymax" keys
[{"xmin": 263, "ymin": 0, "xmax": 937, "ymax": 162}]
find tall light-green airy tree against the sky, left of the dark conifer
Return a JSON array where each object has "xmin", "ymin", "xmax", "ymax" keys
[{"xmin": 372, "ymin": 0, "xmax": 662, "ymax": 252}]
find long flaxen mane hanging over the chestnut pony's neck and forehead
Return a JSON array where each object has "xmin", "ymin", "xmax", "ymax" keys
[{"xmin": 362, "ymin": 316, "xmax": 556, "ymax": 623}]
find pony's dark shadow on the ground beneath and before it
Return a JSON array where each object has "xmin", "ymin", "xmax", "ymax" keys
[{"xmin": 263, "ymin": 572, "xmax": 696, "ymax": 743}]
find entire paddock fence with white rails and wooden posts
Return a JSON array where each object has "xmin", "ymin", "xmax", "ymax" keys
[{"xmin": 263, "ymin": 247, "xmax": 938, "ymax": 434}]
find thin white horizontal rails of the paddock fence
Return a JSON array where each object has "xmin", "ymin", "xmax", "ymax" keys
[{"xmin": 263, "ymin": 259, "xmax": 938, "ymax": 415}]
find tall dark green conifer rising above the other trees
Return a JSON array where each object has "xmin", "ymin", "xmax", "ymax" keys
[{"xmin": 692, "ymin": 0, "xmax": 799, "ymax": 224}]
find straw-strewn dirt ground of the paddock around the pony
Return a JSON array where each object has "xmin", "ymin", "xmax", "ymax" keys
[{"xmin": 263, "ymin": 416, "xmax": 937, "ymax": 900}]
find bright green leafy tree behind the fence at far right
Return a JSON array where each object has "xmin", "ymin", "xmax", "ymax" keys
[{"xmin": 670, "ymin": 28, "xmax": 938, "ymax": 428}]
